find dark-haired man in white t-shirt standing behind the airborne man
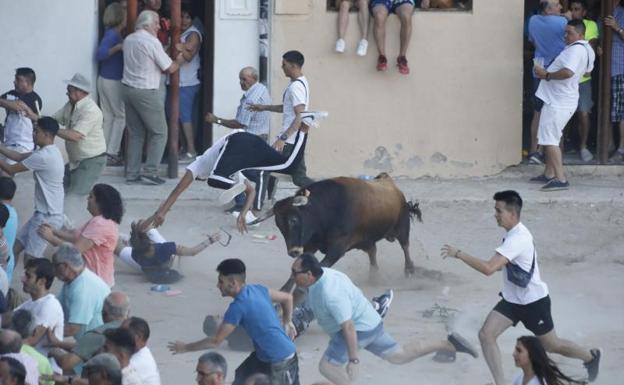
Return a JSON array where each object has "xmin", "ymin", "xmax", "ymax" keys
[{"xmin": 249, "ymin": 51, "xmax": 314, "ymax": 198}]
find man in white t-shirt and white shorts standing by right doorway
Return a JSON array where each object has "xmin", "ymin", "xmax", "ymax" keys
[{"xmin": 531, "ymin": 20, "xmax": 595, "ymax": 191}]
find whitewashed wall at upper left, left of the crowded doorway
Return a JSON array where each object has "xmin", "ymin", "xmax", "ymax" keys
[{"xmin": 0, "ymin": 0, "xmax": 98, "ymax": 121}]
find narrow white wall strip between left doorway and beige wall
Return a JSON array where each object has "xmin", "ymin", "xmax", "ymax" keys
[{"xmin": 212, "ymin": 0, "xmax": 259, "ymax": 140}]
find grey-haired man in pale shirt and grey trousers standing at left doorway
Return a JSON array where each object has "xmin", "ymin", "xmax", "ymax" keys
[{"xmin": 121, "ymin": 10, "xmax": 184, "ymax": 185}]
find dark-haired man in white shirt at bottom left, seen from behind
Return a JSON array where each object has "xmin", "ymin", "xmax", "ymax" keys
[{"xmin": 121, "ymin": 317, "xmax": 160, "ymax": 385}]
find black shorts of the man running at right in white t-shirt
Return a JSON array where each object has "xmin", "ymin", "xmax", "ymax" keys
[{"xmin": 493, "ymin": 296, "xmax": 555, "ymax": 336}]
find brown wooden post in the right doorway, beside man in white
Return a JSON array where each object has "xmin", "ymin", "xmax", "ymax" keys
[{"xmin": 596, "ymin": 0, "xmax": 613, "ymax": 164}]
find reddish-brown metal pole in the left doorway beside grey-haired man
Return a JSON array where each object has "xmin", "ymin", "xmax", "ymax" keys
[{"xmin": 167, "ymin": 0, "xmax": 182, "ymax": 178}]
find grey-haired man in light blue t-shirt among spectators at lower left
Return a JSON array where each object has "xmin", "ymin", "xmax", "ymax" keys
[{"xmin": 48, "ymin": 244, "xmax": 110, "ymax": 339}]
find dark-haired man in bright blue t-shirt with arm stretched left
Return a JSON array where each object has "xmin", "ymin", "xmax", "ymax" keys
[{"xmin": 169, "ymin": 258, "xmax": 299, "ymax": 385}]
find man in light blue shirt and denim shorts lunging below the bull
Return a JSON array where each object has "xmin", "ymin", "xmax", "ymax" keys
[{"xmin": 291, "ymin": 254, "xmax": 478, "ymax": 385}]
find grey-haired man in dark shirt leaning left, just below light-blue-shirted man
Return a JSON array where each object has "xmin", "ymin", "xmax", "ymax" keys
[{"xmin": 48, "ymin": 291, "xmax": 130, "ymax": 372}]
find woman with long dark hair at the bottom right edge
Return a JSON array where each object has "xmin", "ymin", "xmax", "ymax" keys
[{"xmin": 510, "ymin": 336, "xmax": 585, "ymax": 385}]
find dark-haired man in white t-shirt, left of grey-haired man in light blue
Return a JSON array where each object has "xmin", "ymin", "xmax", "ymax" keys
[{"xmin": 15, "ymin": 258, "xmax": 65, "ymax": 373}]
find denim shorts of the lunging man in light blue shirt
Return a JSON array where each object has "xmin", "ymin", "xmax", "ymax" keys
[{"xmin": 323, "ymin": 322, "xmax": 401, "ymax": 365}]
